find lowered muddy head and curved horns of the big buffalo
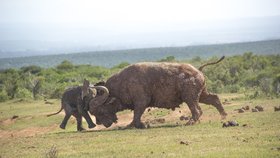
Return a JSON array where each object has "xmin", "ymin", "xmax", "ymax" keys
[{"xmin": 89, "ymin": 86, "xmax": 120, "ymax": 128}]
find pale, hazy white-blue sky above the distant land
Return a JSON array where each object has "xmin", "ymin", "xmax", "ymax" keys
[{"xmin": 0, "ymin": 0, "xmax": 280, "ymax": 55}]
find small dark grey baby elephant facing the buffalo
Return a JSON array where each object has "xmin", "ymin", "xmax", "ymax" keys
[{"xmin": 47, "ymin": 80, "xmax": 96, "ymax": 131}]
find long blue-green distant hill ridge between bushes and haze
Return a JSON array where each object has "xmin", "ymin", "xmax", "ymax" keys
[{"xmin": 0, "ymin": 39, "xmax": 280, "ymax": 69}]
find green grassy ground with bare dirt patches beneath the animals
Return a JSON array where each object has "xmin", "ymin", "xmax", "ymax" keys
[{"xmin": 0, "ymin": 94, "xmax": 280, "ymax": 158}]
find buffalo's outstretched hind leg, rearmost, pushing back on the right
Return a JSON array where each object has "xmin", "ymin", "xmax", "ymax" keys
[{"xmin": 199, "ymin": 89, "xmax": 227, "ymax": 119}]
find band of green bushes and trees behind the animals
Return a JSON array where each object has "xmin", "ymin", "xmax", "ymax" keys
[{"xmin": 0, "ymin": 52, "xmax": 280, "ymax": 102}]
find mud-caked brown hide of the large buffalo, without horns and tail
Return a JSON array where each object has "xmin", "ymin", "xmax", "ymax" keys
[{"xmin": 89, "ymin": 59, "xmax": 226, "ymax": 128}]
